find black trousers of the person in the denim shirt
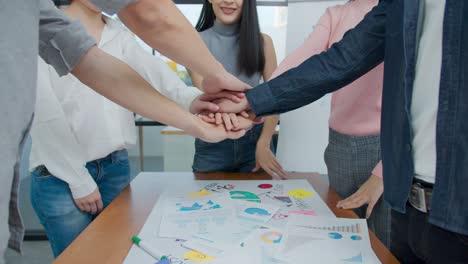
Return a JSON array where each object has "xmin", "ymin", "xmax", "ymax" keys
[{"xmin": 390, "ymin": 204, "xmax": 468, "ymax": 264}]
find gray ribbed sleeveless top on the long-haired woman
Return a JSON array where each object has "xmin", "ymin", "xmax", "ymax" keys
[{"xmin": 200, "ymin": 21, "xmax": 262, "ymax": 87}]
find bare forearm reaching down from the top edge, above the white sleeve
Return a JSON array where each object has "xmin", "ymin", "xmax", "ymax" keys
[{"xmin": 119, "ymin": 0, "xmax": 224, "ymax": 77}]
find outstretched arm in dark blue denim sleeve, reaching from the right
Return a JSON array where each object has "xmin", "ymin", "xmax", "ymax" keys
[{"xmin": 246, "ymin": 1, "xmax": 389, "ymax": 116}]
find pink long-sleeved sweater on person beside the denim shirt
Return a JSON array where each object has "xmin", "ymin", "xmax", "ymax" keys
[{"xmin": 271, "ymin": 0, "xmax": 383, "ymax": 177}]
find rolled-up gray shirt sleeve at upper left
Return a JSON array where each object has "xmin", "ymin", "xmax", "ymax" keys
[{"xmin": 39, "ymin": 0, "xmax": 96, "ymax": 76}]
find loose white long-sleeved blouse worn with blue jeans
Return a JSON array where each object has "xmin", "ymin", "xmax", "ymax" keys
[{"xmin": 30, "ymin": 19, "xmax": 201, "ymax": 199}]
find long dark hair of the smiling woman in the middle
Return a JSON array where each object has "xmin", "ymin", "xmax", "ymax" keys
[{"xmin": 195, "ymin": 0, "xmax": 265, "ymax": 76}]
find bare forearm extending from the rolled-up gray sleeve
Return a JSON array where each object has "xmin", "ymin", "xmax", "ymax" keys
[{"xmin": 72, "ymin": 47, "xmax": 203, "ymax": 135}]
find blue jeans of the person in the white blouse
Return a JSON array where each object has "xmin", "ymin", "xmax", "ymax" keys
[{"xmin": 31, "ymin": 150, "xmax": 130, "ymax": 257}]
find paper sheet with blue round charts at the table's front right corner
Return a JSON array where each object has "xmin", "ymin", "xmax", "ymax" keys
[{"xmin": 281, "ymin": 215, "xmax": 380, "ymax": 264}]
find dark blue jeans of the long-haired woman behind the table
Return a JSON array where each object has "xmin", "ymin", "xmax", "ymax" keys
[{"xmin": 192, "ymin": 124, "xmax": 273, "ymax": 172}]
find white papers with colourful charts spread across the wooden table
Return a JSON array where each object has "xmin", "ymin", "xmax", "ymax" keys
[{"xmin": 124, "ymin": 180, "xmax": 378, "ymax": 264}]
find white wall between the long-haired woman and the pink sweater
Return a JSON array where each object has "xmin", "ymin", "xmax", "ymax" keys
[{"xmin": 277, "ymin": 0, "xmax": 346, "ymax": 173}]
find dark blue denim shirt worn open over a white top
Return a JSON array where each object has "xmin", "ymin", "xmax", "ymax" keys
[{"xmin": 246, "ymin": 0, "xmax": 468, "ymax": 235}]
